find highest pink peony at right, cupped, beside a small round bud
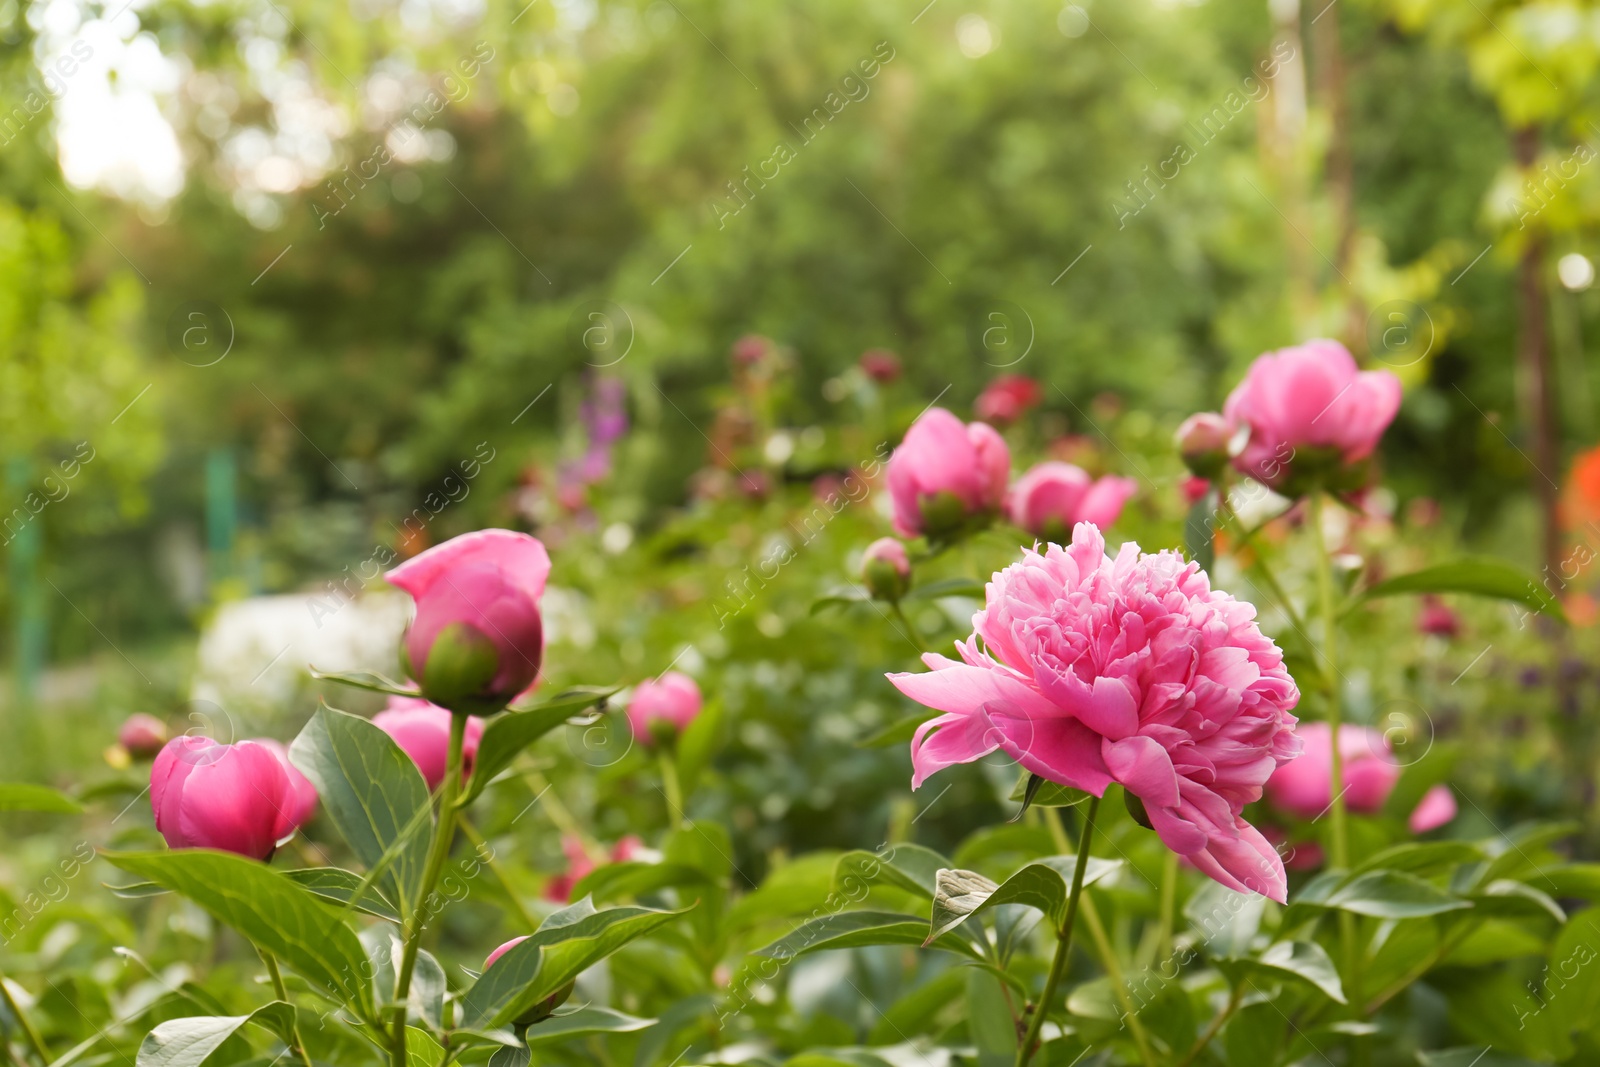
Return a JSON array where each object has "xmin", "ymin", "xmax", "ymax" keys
[{"xmin": 1224, "ymin": 341, "xmax": 1400, "ymax": 496}]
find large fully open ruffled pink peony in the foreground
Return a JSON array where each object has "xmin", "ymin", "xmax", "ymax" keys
[{"xmin": 890, "ymin": 523, "xmax": 1299, "ymax": 901}]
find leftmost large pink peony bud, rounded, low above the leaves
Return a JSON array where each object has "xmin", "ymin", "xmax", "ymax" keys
[{"xmin": 150, "ymin": 736, "xmax": 317, "ymax": 859}]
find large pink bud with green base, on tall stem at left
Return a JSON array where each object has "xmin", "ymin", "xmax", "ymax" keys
[{"xmin": 386, "ymin": 530, "xmax": 550, "ymax": 713}]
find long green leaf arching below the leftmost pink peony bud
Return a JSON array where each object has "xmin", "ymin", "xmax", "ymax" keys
[{"xmin": 102, "ymin": 848, "xmax": 374, "ymax": 1019}]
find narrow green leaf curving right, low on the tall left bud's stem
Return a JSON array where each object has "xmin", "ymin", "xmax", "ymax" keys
[{"xmin": 461, "ymin": 905, "xmax": 693, "ymax": 1030}]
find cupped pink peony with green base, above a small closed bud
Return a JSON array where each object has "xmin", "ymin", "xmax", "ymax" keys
[{"xmin": 888, "ymin": 408, "xmax": 1011, "ymax": 537}]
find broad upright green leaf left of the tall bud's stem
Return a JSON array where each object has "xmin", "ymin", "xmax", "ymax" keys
[{"xmin": 290, "ymin": 705, "xmax": 429, "ymax": 915}]
